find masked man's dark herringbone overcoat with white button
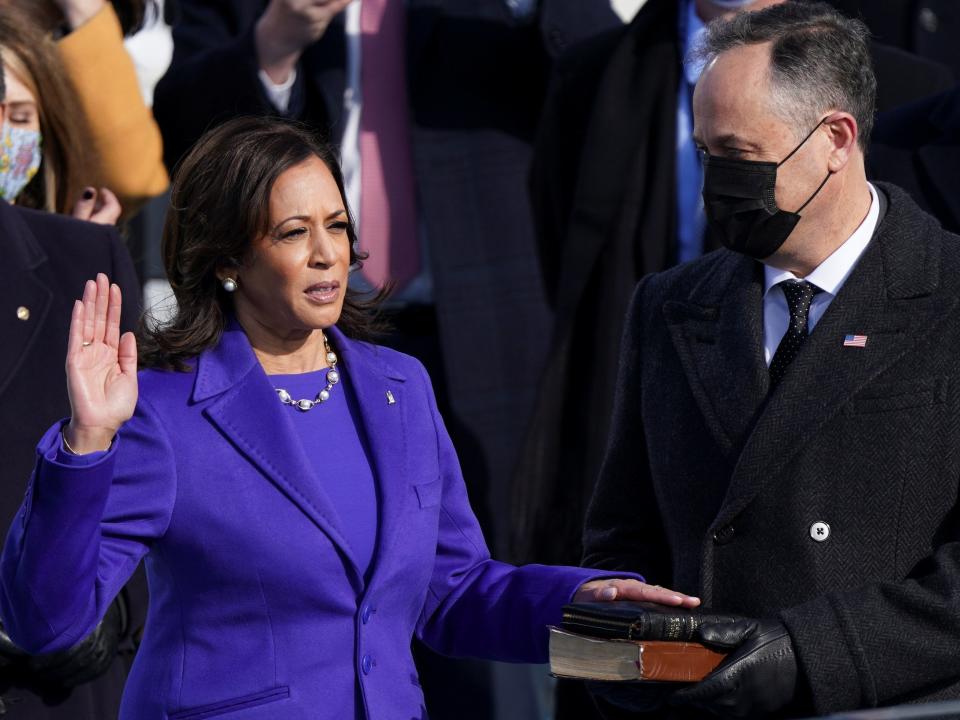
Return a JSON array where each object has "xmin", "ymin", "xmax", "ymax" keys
[{"xmin": 584, "ymin": 185, "xmax": 960, "ymax": 714}]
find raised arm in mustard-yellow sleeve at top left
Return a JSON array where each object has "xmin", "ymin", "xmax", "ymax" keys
[{"xmin": 58, "ymin": 0, "xmax": 169, "ymax": 217}]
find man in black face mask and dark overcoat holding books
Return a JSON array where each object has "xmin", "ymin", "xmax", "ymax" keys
[{"xmin": 584, "ymin": 2, "xmax": 960, "ymax": 717}]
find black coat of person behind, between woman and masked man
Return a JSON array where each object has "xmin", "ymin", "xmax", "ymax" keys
[{"xmin": 513, "ymin": 0, "xmax": 681, "ymax": 563}]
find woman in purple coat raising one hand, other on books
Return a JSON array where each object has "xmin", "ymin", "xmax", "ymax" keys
[{"xmin": 0, "ymin": 119, "xmax": 696, "ymax": 720}]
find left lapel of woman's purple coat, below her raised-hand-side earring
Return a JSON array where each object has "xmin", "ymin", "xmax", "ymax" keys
[{"xmin": 193, "ymin": 325, "xmax": 363, "ymax": 588}]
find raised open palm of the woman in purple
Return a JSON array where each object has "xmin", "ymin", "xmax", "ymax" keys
[{"xmin": 63, "ymin": 273, "xmax": 137, "ymax": 454}]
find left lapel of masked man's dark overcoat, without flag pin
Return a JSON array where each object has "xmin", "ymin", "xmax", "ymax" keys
[{"xmin": 663, "ymin": 251, "xmax": 768, "ymax": 456}]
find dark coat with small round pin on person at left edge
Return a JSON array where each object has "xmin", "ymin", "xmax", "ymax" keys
[{"xmin": 0, "ymin": 201, "xmax": 146, "ymax": 720}]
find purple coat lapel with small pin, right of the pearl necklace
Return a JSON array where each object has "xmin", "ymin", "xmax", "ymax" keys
[{"xmin": 330, "ymin": 328, "xmax": 412, "ymax": 577}]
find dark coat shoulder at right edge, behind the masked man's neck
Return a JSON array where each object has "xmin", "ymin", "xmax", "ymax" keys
[{"xmin": 867, "ymin": 86, "xmax": 960, "ymax": 233}]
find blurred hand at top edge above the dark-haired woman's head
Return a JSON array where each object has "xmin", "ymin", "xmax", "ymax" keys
[{"xmin": 254, "ymin": 0, "xmax": 352, "ymax": 85}]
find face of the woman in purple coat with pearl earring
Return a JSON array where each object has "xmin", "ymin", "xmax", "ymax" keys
[{"xmin": 232, "ymin": 157, "xmax": 350, "ymax": 340}]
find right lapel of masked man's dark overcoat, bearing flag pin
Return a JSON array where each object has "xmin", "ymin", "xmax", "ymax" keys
[{"xmin": 713, "ymin": 188, "xmax": 944, "ymax": 528}]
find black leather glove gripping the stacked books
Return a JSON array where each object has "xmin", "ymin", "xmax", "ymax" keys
[{"xmin": 670, "ymin": 620, "xmax": 797, "ymax": 718}]
